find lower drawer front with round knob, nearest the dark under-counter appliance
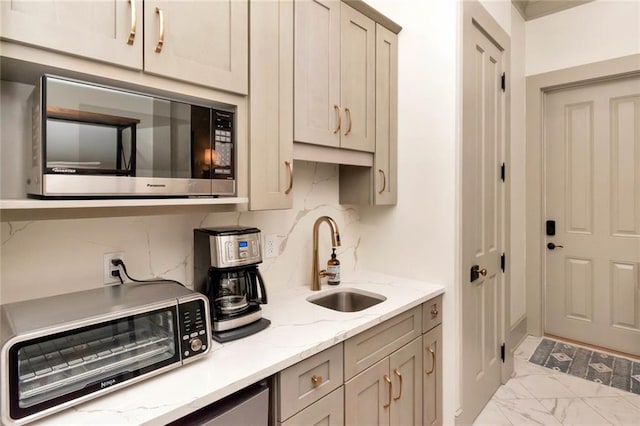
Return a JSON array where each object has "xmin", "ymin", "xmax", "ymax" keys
[{"xmin": 279, "ymin": 343, "xmax": 344, "ymax": 421}]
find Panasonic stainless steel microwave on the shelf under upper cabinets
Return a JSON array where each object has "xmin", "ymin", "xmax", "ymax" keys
[{"xmin": 27, "ymin": 75, "xmax": 236, "ymax": 198}]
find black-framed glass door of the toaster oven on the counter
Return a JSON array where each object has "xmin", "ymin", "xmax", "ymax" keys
[{"xmin": 9, "ymin": 306, "xmax": 180, "ymax": 419}]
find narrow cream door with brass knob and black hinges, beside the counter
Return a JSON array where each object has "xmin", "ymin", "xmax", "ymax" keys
[{"xmin": 458, "ymin": 5, "xmax": 505, "ymax": 424}]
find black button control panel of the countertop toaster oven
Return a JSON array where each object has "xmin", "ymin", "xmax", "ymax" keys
[{"xmin": 178, "ymin": 299, "xmax": 209, "ymax": 361}]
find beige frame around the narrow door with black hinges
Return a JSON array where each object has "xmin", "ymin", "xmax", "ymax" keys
[{"xmin": 455, "ymin": 0, "xmax": 517, "ymax": 425}]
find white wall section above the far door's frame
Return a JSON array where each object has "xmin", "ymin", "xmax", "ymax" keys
[{"xmin": 526, "ymin": 0, "xmax": 640, "ymax": 75}]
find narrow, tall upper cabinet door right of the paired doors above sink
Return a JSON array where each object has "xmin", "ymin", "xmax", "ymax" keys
[{"xmin": 373, "ymin": 24, "xmax": 398, "ymax": 205}]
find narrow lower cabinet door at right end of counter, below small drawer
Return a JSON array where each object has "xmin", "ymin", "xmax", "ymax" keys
[{"xmin": 422, "ymin": 325, "xmax": 442, "ymax": 426}]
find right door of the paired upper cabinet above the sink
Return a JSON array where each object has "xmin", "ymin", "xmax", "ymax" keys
[{"xmin": 340, "ymin": 3, "xmax": 376, "ymax": 152}]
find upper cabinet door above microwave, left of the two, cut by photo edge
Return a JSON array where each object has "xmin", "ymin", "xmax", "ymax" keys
[{"xmin": 0, "ymin": 0, "xmax": 142, "ymax": 69}]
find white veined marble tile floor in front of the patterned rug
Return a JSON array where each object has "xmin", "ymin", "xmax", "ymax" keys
[{"xmin": 473, "ymin": 336, "xmax": 640, "ymax": 426}]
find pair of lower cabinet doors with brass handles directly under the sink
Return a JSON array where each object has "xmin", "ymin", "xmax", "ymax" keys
[{"xmin": 345, "ymin": 338, "xmax": 422, "ymax": 425}]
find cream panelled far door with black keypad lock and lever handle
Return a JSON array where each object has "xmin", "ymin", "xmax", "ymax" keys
[{"xmin": 544, "ymin": 76, "xmax": 640, "ymax": 355}]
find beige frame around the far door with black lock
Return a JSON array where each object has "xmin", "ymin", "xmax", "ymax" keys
[{"xmin": 525, "ymin": 54, "xmax": 640, "ymax": 336}]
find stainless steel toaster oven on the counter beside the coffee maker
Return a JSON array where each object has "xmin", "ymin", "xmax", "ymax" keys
[{"xmin": 0, "ymin": 282, "xmax": 211, "ymax": 424}]
